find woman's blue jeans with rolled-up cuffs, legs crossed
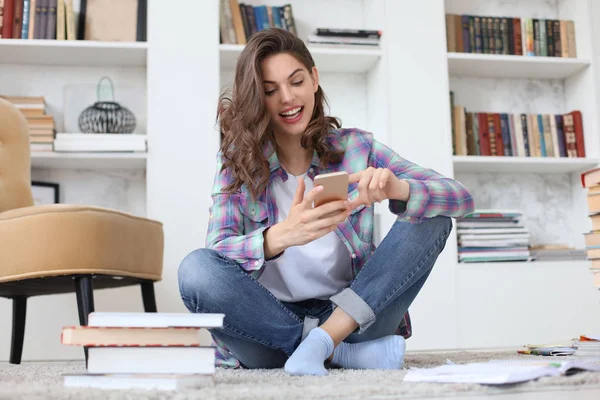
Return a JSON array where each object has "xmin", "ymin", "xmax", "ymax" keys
[{"xmin": 179, "ymin": 216, "xmax": 452, "ymax": 368}]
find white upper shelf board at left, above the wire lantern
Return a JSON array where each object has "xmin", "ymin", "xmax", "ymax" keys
[{"xmin": 0, "ymin": 39, "xmax": 148, "ymax": 67}]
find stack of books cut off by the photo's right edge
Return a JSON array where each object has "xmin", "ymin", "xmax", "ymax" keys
[{"xmin": 581, "ymin": 168, "xmax": 600, "ymax": 289}]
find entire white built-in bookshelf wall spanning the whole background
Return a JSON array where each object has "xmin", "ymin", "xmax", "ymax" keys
[{"xmin": 0, "ymin": 0, "xmax": 600, "ymax": 360}]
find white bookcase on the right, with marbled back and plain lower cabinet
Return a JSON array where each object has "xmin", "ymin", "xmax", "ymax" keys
[{"xmin": 444, "ymin": 0, "xmax": 600, "ymax": 348}]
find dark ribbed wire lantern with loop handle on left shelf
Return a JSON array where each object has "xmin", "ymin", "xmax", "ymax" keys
[{"xmin": 79, "ymin": 76, "xmax": 136, "ymax": 133}]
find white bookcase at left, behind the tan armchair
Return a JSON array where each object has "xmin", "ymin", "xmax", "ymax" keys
[{"xmin": 0, "ymin": 0, "xmax": 150, "ymax": 361}]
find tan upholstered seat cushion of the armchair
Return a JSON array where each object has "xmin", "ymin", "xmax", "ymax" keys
[{"xmin": 0, "ymin": 204, "xmax": 163, "ymax": 283}]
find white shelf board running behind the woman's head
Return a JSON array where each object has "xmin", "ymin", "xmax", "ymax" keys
[{"xmin": 219, "ymin": 44, "xmax": 383, "ymax": 73}]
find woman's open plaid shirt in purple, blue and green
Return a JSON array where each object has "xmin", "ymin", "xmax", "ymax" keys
[{"xmin": 206, "ymin": 129, "xmax": 474, "ymax": 367}]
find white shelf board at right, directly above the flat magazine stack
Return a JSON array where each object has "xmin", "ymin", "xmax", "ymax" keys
[{"xmin": 452, "ymin": 156, "xmax": 600, "ymax": 174}]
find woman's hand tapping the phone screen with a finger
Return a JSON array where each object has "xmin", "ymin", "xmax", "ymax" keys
[{"xmin": 348, "ymin": 167, "xmax": 410, "ymax": 210}]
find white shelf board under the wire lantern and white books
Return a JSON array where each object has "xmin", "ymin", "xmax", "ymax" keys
[{"xmin": 31, "ymin": 152, "xmax": 147, "ymax": 169}]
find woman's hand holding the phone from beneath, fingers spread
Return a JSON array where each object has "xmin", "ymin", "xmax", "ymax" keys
[{"xmin": 265, "ymin": 177, "xmax": 350, "ymax": 256}]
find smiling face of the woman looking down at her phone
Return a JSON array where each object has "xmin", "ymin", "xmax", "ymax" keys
[{"xmin": 261, "ymin": 53, "xmax": 319, "ymax": 138}]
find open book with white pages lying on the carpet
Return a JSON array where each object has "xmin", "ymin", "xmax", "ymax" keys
[{"xmin": 404, "ymin": 358, "xmax": 600, "ymax": 385}]
